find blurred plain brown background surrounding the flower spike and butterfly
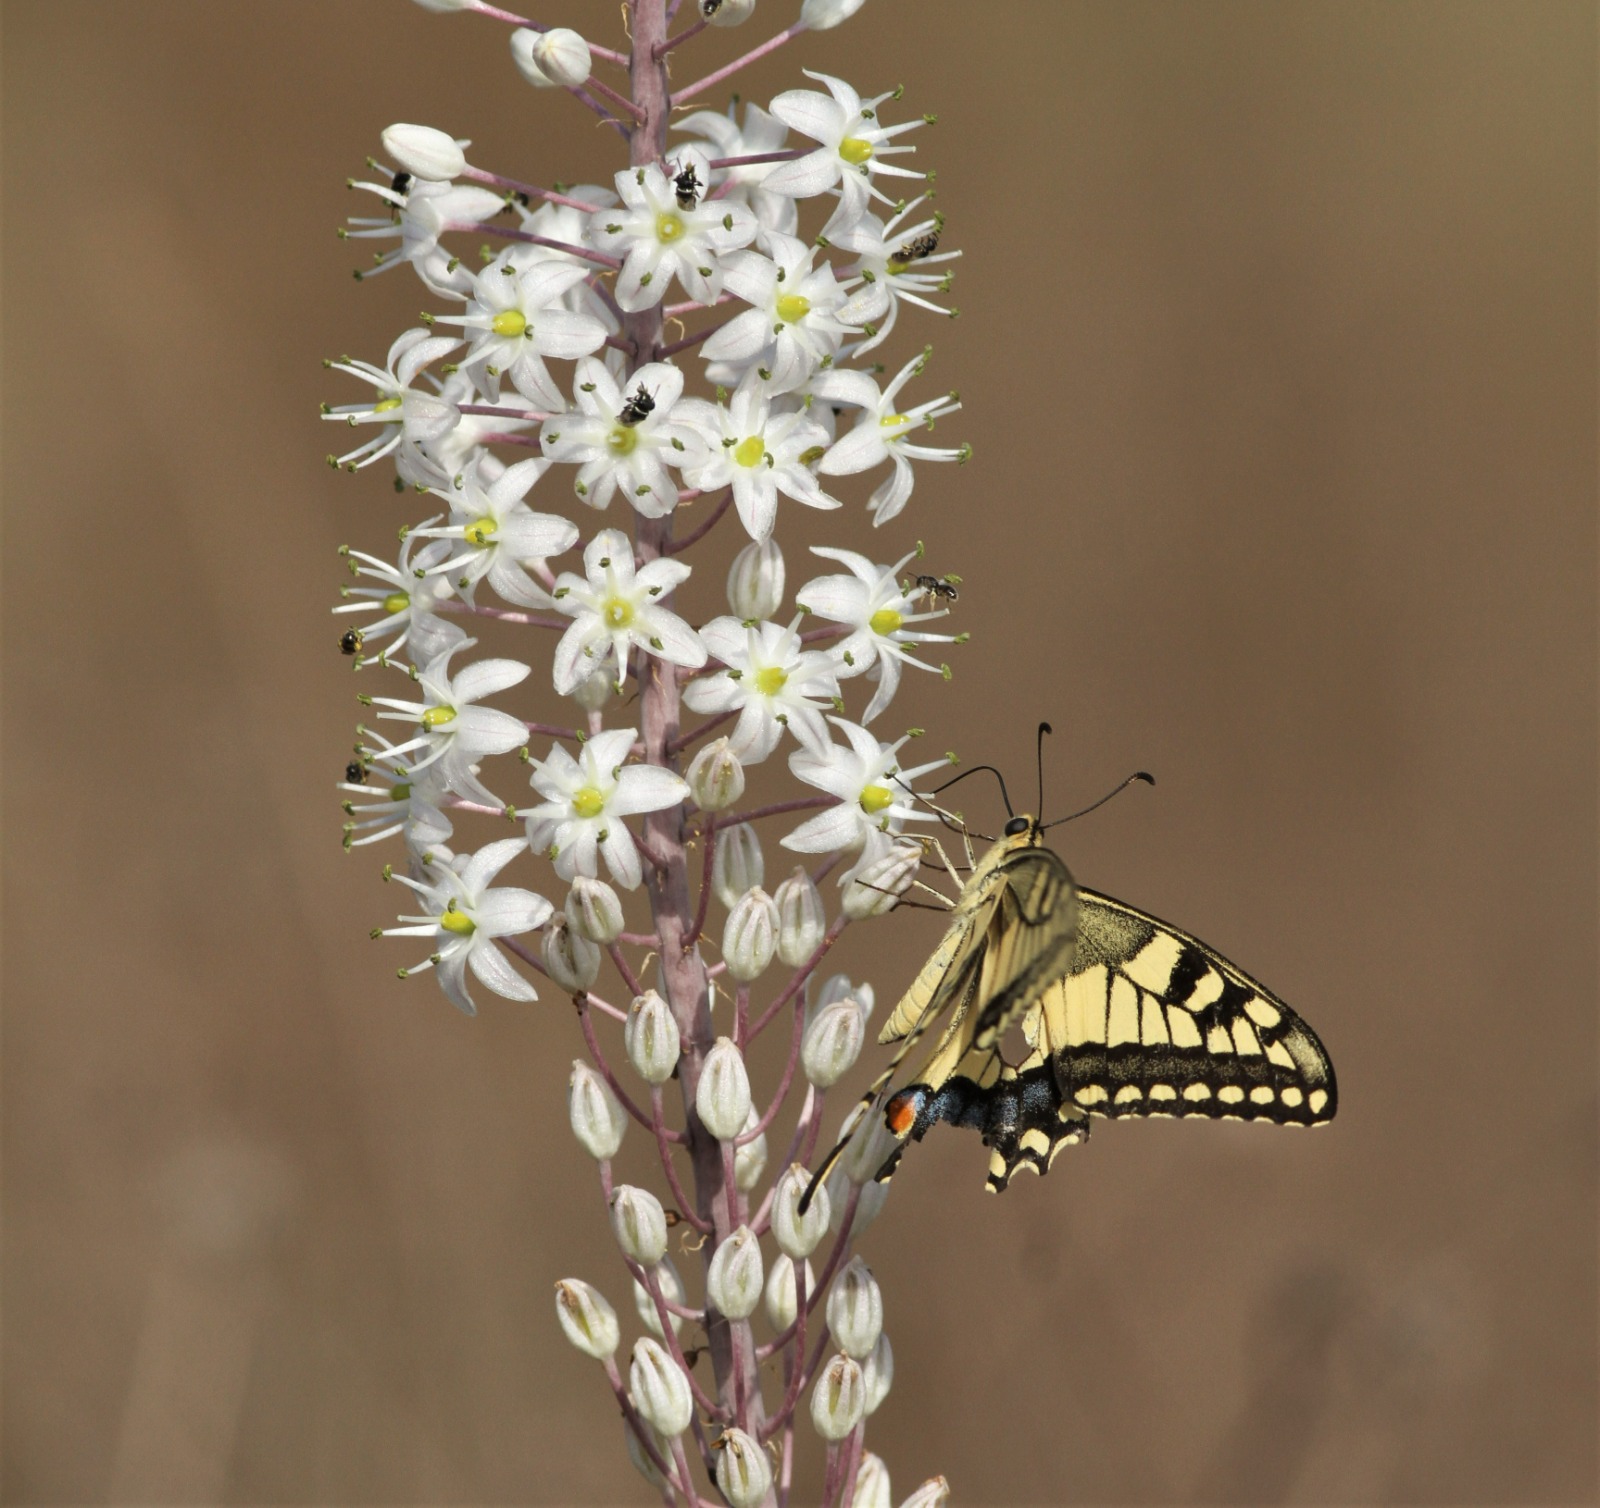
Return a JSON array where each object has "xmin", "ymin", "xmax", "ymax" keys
[{"xmin": 3, "ymin": 0, "xmax": 1597, "ymax": 1505}]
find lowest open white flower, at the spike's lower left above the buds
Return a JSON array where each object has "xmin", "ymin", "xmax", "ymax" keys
[{"xmin": 384, "ymin": 837, "xmax": 550, "ymax": 1017}]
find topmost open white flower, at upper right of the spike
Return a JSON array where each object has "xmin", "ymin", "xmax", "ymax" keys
[{"xmin": 763, "ymin": 69, "xmax": 923, "ymax": 235}]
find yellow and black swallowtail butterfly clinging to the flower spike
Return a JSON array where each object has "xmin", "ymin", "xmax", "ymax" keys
[{"xmin": 819, "ymin": 736, "xmax": 1338, "ymax": 1193}]
